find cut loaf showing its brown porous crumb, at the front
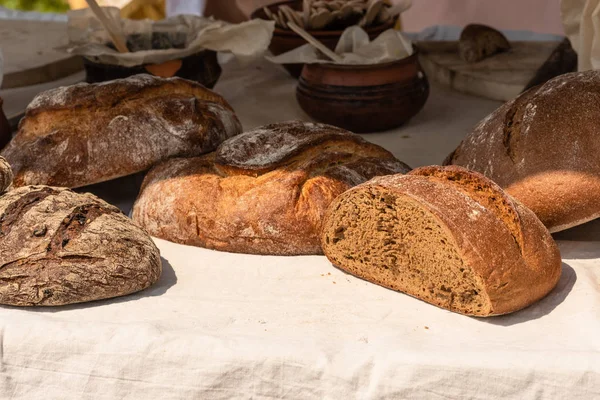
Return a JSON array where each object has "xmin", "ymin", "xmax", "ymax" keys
[{"xmin": 322, "ymin": 167, "xmax": 561, "ymax": 317}]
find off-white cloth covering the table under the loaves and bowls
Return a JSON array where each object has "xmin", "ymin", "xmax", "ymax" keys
[{"xmin": 0, "ymin": 57, "xmax": 600, "ymax": 400}]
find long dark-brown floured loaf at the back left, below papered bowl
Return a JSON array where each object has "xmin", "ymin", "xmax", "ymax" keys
[{"xmin": 2, "ymin": 75, "xmax": 241, "ymax": 188}]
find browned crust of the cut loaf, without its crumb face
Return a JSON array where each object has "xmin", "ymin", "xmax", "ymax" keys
[{"xmin": 321, "ymin": 167, "xmax": 561, "ymax": 316}]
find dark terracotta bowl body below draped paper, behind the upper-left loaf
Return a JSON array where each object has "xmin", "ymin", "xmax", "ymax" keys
[{"xmin": 83, "ymin": 33, "xmax": 221, "ymax": 88}]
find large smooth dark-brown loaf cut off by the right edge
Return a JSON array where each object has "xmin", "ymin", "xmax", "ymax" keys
[{"xmin": 444, "ymin": 71, "xmax": 600, "ymax": 232}]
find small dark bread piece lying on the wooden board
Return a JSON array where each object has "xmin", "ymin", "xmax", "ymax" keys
[{"xmin": 458, "ymin": 24, "xmax": 510, "ymax": 63}]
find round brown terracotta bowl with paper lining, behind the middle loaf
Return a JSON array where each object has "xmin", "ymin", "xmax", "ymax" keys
[{"xmin": 296, "ymin": 51, "xmax": 429, "ymax": 133}]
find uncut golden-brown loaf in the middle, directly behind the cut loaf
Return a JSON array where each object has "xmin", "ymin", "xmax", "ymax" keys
[{"xmin": 133, "ymin": 122, "xmax": 409, "ymax": 255}]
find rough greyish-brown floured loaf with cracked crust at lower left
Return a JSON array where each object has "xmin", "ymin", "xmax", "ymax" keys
[{"xmin": 0, "ymin": 186, "xmax": 162, "ymax": 306}]
